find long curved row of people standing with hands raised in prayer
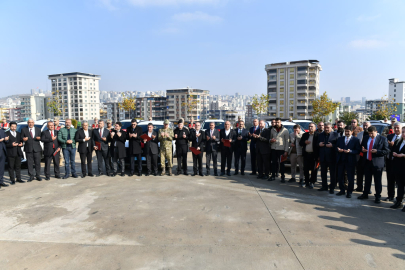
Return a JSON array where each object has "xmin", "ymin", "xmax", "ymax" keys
[{"xmin": 0, "ymin": 118, "xmax": 405, "ymax": 212}]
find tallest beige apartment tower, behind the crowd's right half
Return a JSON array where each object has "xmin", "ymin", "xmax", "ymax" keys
[{"xmin": 265, "ymin": 60, "xmax": 322, "ymax": 119}]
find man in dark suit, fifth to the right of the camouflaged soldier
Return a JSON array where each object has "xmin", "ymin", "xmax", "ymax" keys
[{"xmin": 234, "ymin": 120, "xmax": 249, "ymax": 175}]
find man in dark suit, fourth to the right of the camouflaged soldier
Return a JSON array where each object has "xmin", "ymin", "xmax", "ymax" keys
[{"xmin": 219, "ymin": 121, "xmax": 236, "ymax": 176}]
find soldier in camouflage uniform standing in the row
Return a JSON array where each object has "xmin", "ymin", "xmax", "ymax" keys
[{"xmin": 158, "ymin": 119, "xmax": 174, "ymax": 176}]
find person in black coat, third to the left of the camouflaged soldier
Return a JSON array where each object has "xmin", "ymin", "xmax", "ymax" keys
[{"xmin": 108, "ymin": 122, "xmax": 127, "ymax": 176}]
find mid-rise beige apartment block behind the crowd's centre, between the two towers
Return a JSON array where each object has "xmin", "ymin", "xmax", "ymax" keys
[{"xmin": 166, "ymin": 87, "xmax": 209, "ymax": 121}]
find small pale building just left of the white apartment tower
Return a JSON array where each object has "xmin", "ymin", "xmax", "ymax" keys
[{"xmin": 20, "ymin": 94, "xmax": 46, "ymax": 120}]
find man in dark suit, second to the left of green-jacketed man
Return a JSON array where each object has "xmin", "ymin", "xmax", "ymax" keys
[{"xmin": 21, "ymin": 119, "xmax": 42, "ymax": 182}]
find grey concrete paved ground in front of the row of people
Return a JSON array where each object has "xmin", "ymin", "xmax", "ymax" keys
[{"xmin": 0, "ymin": 153, "xmax": 405, "ymax": 269}]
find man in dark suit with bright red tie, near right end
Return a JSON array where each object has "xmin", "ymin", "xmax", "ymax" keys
[{"xmin": 358, "ymin": 126, "xmax": 390, "ymax": 203}]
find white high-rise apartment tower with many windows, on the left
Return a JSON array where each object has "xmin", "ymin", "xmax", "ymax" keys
[{"xmin": 48, "ymin": 72, "xmax": 101, "ymax": 120}]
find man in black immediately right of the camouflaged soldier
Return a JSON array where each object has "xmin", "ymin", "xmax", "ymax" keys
[{"xmin": 173, "ymin": 119, "xmax": 190, "ymax": 175}]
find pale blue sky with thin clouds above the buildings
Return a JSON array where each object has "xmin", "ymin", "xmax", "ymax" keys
[{"xmin": 0, "ymin": 0, "xmax": 405, "ymax": 100}]
